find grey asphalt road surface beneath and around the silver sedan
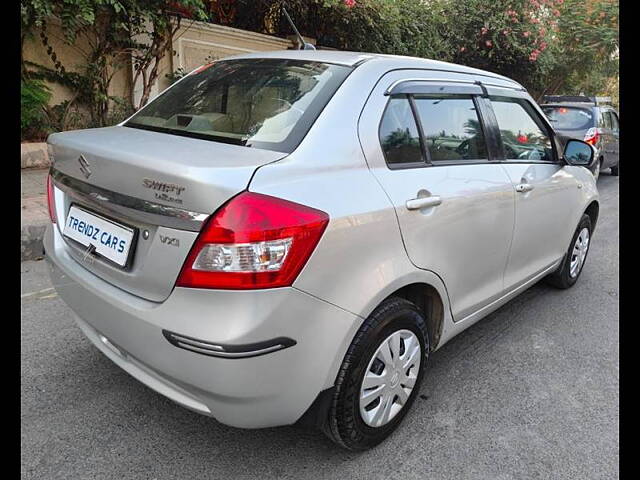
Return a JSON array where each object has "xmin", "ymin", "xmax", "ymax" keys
[{"xmin": 21, "ymin": 174, "xmax": 619, "ymax": 480}]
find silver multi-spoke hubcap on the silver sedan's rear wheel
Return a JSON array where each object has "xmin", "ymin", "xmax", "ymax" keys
[{"xmin": 360, "ymin": 330, "xmax": 422, "ymax": 427}]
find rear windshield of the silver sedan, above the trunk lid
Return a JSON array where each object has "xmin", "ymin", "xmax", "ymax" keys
[{"xmin": 125, "ymin": 59, "xmax": 352, "ymax": 153}]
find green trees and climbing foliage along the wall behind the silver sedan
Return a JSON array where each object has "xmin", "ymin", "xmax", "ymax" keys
[{"xmin": 21, "ymin": 0, "xmax": 619, "ymax": 131}]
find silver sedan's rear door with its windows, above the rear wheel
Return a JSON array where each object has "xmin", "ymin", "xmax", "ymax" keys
[{"xmin": 359, "ymin": 70, "xmax": 514, "ymax": 321}]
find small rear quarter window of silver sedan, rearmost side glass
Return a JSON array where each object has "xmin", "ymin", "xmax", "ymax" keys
[{"xmin": 379, "ymin": 96, "xmax": 425, "ymax": 167}]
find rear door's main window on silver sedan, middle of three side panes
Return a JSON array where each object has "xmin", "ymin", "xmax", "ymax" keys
[{"xmin": 414, "ymin": 95, "xmax": 489, "ymax": 163}]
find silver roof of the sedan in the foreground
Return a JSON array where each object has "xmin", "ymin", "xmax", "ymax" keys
[{"xmin": 225, "ymin": 50, "xmax": 522, "ymax": 87}]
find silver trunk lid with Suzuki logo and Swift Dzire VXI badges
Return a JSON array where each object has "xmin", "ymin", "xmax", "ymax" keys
[{"xmin": 48, "ymin": 126, "xmax": 286, "ymax": 302}]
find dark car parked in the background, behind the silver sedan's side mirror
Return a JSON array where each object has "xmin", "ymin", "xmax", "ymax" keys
[{"xmin": 540, "ymin": 95, "xmax": 620, "ymax": 179}]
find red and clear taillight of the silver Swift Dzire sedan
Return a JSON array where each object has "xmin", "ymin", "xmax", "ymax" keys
[{"xmin": 176, "ymin": 192, "xmax": 329, "ymax": 290}]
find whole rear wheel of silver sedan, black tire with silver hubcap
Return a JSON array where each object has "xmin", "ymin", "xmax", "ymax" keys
[{"xmin": 323, "ymin": 297, "xmax": 430, "ymax": 451}]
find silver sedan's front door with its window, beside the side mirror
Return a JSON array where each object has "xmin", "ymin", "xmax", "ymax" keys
[{"xmin": 489, "ymin": 89, "xmax": 584, "ymax": 289}]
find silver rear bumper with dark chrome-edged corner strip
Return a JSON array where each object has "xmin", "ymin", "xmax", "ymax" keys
[{"xmin": 44, "ymin": 227, "xmax": 359, "ymax": 428}]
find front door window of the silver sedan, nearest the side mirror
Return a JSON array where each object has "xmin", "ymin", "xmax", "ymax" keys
[{"xmin": 491, "ymin": 97, "xmax": 554, "ymax": 162}]
